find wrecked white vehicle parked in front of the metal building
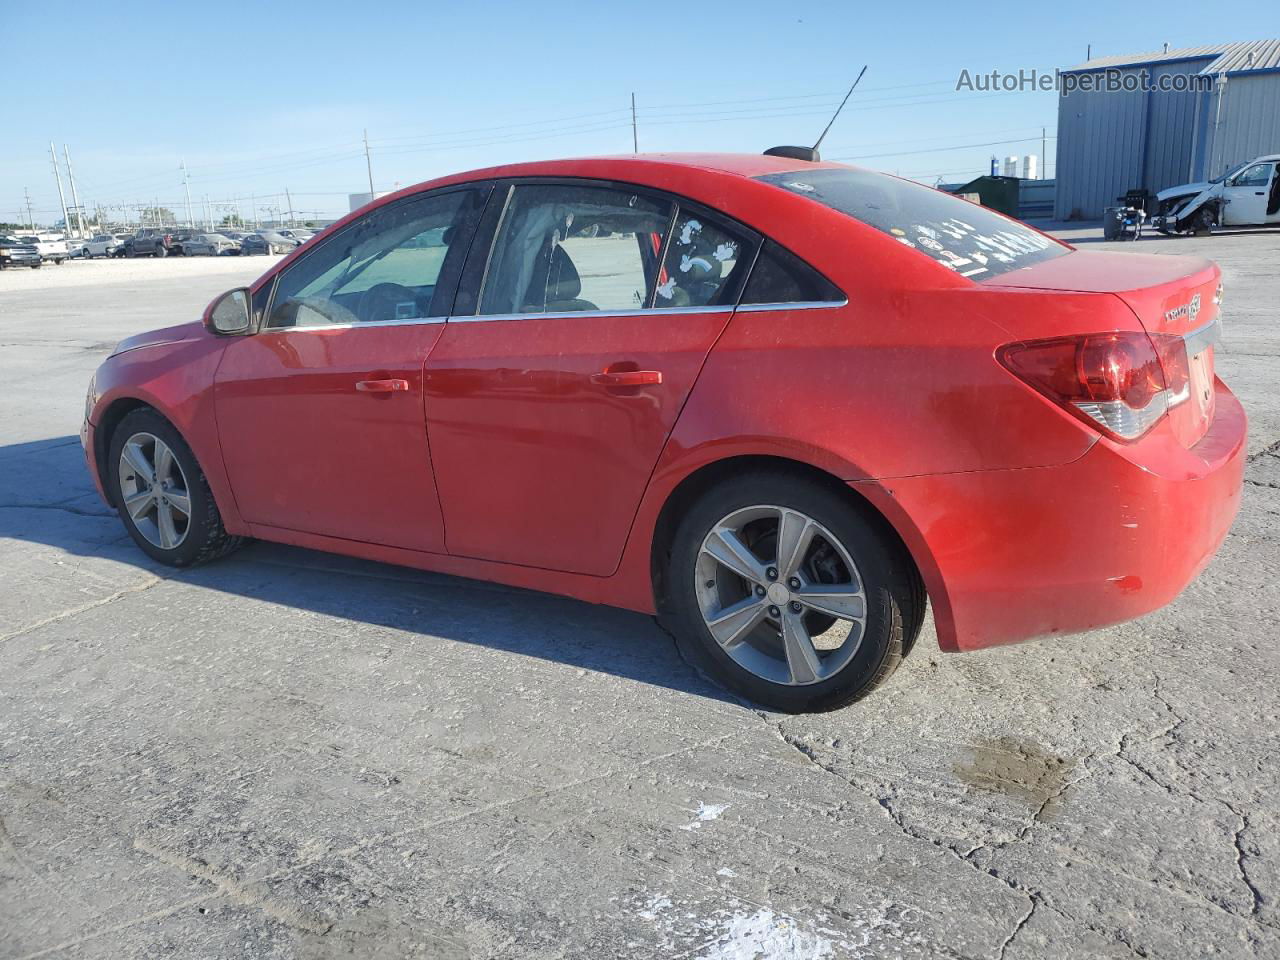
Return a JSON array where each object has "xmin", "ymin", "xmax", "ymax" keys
[{"xmin": 1151, "ymin": 154, "xmax": 1280, "ymax": 233}]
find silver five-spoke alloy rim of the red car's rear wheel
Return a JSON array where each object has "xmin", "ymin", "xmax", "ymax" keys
[{"xmin": 694, "ymin": 504, "xmax": 867, "ymax": 686}]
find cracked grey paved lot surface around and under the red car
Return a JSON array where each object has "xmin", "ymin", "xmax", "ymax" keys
[{"xmin": 0, "ymin": 232, "xmax": 1280, "ymax": 960}]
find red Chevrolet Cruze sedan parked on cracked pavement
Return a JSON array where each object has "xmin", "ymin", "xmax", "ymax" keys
[{"xmin": 83, "ymin": 155, "xmax": 1245, "ymax": 710}]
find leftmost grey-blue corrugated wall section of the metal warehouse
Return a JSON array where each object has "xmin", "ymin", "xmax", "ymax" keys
[{"xmin": 1053, "ymin": 67, "xmax": 1147, "ymax": 220}]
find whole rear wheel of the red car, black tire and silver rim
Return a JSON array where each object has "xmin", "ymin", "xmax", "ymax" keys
[{"xmin": 667, "ymin": 471, "xmax": 923, "ymax": 712}]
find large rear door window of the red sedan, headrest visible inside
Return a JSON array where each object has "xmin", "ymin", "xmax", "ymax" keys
[{"xmin": 479, "ymin": 184, "xmax": 672, "ymax": 316}]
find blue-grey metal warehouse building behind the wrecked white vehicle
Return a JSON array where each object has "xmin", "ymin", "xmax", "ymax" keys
[{"xmin": 1053, "ymin": 40, "xmax": 1280, "ymax": 220}]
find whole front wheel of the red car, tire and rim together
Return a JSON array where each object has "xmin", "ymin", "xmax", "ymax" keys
[{"xmin": 106, "ymin": 408, "xmax": 242, "ymax": 567}]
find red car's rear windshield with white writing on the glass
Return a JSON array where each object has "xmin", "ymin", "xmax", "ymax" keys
[{"xmin": 756, "ymin": 169, "xmax": 1070, "ymax": 280}]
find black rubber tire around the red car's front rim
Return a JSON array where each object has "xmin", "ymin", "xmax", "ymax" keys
[{"xmin": 104, "ymin": 407, "xmax": 244, "ymax": 567}]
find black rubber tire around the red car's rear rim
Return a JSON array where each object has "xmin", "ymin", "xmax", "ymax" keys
[{"xmin": 663, "ymin": 470, "xmax": 925, "ymax": 713}]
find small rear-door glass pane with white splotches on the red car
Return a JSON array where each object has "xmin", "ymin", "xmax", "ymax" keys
[{"xmin": 654, "ymin": 209, "xmax": 749, "ymax": 308}]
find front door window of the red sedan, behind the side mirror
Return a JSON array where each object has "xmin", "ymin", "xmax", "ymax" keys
[{"xmin": 266, "ymin": 189, "xmax": 479, "ymax": 328}]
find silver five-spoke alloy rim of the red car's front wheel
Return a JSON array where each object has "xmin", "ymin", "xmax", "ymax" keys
[{"xmin": 119, "ymin": 433, "xmax": 191, "ymax": 550}]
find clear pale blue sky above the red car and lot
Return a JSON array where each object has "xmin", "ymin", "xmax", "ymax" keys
[{"xmin": 0, "ymin": 0, "xmax": 1239, "ymax": 223}]
